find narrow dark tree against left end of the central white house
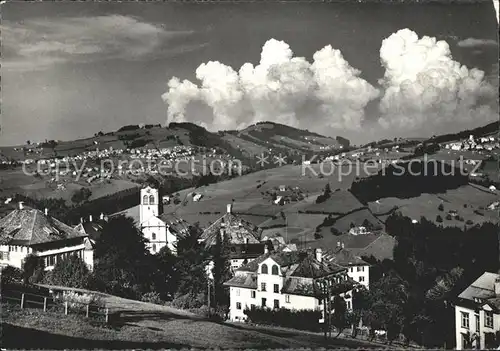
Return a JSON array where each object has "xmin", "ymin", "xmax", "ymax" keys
[{"xmin": 212, "ymin": 235, "xmax": 233, "ymax": 306}]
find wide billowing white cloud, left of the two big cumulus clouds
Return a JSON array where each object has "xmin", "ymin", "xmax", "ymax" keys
[{"xmin": 162, "ymin": 39, "xmax": 379, "ymax": 129}]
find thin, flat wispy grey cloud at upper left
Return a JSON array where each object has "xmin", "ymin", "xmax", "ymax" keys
[{"xmin": 0, "ymin": 15, "xmax": 203, "ymax": 71}]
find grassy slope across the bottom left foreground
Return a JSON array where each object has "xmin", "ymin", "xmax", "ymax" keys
[{"xmin": 2, "ymin": 296, "xmax": 381, "ymax": 349}]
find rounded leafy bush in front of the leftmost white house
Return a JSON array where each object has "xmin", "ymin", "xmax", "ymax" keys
[{"xmin": 48, "ymin": 254, "xmax": 90, "ymax": 288}]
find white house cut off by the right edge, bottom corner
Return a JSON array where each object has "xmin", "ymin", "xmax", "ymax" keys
[{"xmin": 455, "ymin": 272, "xmax": 500, "ymax": 350}]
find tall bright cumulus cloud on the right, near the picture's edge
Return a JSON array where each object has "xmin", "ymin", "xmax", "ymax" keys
[{"xmin": 379, "ymin": 29, "xmax": 495, "ymax": 130}]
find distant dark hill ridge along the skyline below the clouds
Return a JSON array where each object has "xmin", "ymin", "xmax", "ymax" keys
[{"xmin": 0, "ymin": 122, "xmax": 349, "ymax": 161}]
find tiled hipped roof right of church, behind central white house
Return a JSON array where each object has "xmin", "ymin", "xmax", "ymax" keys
[{"xmin": 200, "ymin": 213, "xmax": 260, "ymax": 246}]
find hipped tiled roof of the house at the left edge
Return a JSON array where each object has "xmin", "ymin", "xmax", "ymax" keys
[{"xmin": 0, "ymin": 208, "xmax": 87, "ymax": 246}]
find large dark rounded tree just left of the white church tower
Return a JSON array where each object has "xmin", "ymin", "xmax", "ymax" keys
[{"xmin": 94, "ymin": 216, "xmax": 155, "ymax": 298}]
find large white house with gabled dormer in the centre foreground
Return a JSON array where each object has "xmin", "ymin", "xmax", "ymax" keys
[{"xmin": 224, "ymin": 249, "xmax": 350, "ymax": 321}]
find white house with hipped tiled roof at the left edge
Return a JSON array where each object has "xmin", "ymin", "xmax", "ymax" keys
[{"xmin": 0, "ymin": 202, "xmax": 94, "ymax": 270}]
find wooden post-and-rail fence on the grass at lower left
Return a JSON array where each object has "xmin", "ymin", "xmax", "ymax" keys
[{"xmin": 1, "ymin": 290, "xmax": 110, "ymax": 323}]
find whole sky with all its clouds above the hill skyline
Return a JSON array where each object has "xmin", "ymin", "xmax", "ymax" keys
[{"xmin": 0, "ymin": 2, "xmax": 498, "ymax": 146}]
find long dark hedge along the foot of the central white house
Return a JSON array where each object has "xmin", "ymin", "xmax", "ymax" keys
[{"xmin": 244, "ymin": 307, "xmax": 321, "ymax": 331}]
